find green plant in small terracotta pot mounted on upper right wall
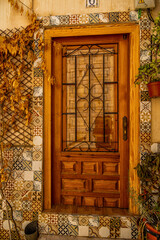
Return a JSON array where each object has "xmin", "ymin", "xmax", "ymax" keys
[{"xmin": 135, "ymin": 13, "xmax": 160, "ymax": 97}]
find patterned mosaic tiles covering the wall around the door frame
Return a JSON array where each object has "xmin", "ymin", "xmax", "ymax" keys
[{"xmin": 0, "ymin": 11, "xmax": 151, "ymax": 240}]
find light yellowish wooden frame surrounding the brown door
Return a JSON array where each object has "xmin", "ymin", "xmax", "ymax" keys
[{"xmin": 43, "ymin": 23, "xmax": 140, "ymax": 214}]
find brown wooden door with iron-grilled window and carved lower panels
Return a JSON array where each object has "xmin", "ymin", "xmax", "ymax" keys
[{"xmin": 52, "ymin": 35, "xmax": 129, "ymax": 208}]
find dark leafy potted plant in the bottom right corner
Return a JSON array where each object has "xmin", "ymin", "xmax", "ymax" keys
[{"xmin": 135, "ymin": 153, "xmax": 160, "ymax": 240}]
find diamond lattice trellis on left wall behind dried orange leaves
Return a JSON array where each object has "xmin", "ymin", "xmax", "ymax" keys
[{"xmin": 0, "ymin": 28, "xmax": 33, "ymax": 146}]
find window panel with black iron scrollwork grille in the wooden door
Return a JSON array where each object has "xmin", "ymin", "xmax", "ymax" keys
[{"xmin": 62, "ymin": 44, "xmax": 118, "ymax": 152}]
